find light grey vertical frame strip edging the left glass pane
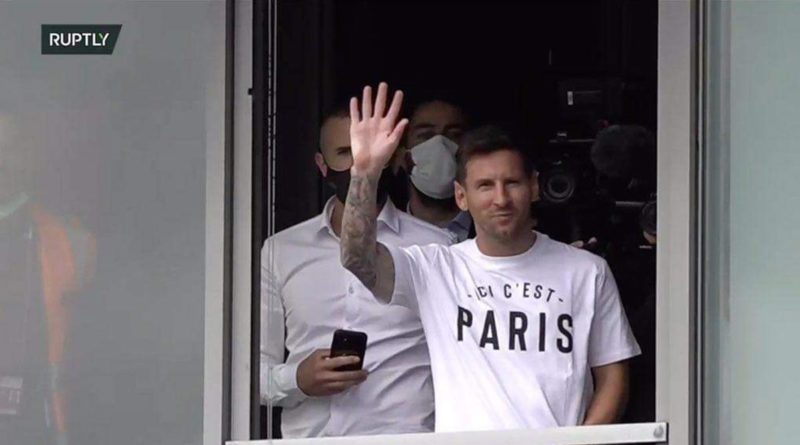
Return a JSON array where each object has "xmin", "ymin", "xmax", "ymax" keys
[{"xmin": 203, "ymin": 0, "xmax": 234, "ymax": 445}]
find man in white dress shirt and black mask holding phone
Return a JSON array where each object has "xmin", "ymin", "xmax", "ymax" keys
[{"xmin": 261, "ymin": 108, "xmax": 450, "ymax": 438}]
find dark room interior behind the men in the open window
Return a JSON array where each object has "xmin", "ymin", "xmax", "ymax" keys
[{"xmin": 255, "ymin": 0, "xmax": 658, "ymax": 437}]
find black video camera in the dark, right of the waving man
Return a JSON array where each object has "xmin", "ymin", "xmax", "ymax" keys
[{"xmin": 534, "ymin": 125, "xmax": 656, "ymax": 253}]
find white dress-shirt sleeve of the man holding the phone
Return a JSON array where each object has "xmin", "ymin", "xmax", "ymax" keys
[{"xmin": 259, "ymin": 241, "xmax": 307, "ymax": 408}]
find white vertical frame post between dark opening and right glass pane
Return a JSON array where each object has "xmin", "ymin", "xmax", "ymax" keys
[{"xmin": 656, "ymin": 0, "xmax": 700, "ymax": 445}]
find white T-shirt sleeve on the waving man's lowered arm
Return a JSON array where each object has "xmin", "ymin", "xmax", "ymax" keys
[{"xmin": 589, "ymin": 261, "xmax": 642, "ymax": 368}]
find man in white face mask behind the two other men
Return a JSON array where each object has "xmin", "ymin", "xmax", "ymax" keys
[{"xmin": 404, "ymin": 100, "xmax": 472, "ymax": 242}]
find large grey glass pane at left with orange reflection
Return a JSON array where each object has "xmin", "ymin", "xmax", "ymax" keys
[{"xmin": 0, "ymin": 1, "xmax": 224, "ymax": 444}]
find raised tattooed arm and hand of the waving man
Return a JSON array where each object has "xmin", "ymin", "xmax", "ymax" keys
[{"xmin": 341, "ymin": 83, "xmax": 408, "ymax": 302}]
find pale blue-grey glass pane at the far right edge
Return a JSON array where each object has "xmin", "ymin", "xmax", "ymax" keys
[{"xmin": 703, "ymin": 1, "xmax": 800, "ymax": 444}]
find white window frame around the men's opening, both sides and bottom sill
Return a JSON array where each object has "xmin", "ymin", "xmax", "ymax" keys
[{"xmin": 227, "ymin": 0, "xmax": 700, "ymax": 445}]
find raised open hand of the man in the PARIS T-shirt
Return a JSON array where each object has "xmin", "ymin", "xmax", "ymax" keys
[{"xmin": 350, "ymin": 82, "xmax": 408, "ymax": 177}]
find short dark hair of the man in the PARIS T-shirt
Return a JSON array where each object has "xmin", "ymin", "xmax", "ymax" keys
[{"xmin": 456, "ymin": 125, "xmax": 536, "ymax": 184}]
